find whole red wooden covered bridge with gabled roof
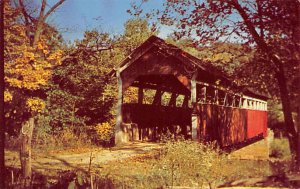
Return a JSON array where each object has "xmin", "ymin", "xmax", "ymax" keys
[{"xmin": 110, "ymin": 36, "xmax": 267, "ymax": 147}]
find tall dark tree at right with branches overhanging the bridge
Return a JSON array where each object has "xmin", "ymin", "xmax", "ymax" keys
[{"xmin": 134, "ymin": 0, "xmax": 300, "ymax": 162}]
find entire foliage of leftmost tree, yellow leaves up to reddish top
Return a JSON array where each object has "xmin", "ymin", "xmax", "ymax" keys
[{"xmin": 4, "ymin": 3, "xmax": 62, "ymax": 93}]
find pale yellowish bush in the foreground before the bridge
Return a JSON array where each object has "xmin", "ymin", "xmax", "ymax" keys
[{"xmin": 154, "ymin": 141, "xmax": 227, "ymax": 187}]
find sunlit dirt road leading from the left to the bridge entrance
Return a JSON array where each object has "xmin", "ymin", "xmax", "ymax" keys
[{"xmin": 5, "ymin": 142, "xmax": 161, "ymax": 172}]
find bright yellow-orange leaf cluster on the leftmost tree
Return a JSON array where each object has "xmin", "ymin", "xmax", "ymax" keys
[{"xmin": 5, "ymin": 32, "xmax": 62, "ymax": 90}]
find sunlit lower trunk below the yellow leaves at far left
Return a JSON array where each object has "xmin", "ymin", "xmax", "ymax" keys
[{"xmin": 20, "ymin": 117, "xmax": 34, "ymax": 187}]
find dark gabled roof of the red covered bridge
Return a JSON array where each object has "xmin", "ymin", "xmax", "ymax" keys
[{"xmin": 109, "ymin": 36, "xmax": 268, "ymax": 100}]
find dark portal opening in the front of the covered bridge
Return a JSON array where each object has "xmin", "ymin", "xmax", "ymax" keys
[{"xmin": 121, "ymin": 74, "xmax": 192, "ymax": 141}]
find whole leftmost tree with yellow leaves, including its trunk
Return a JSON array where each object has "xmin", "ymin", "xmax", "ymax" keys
[{"xmin": 4, "ymin": 0, "xmax": 64, "ymax": 183}]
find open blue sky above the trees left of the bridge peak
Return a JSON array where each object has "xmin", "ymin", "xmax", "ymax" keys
[{"xmin": 47, "ymin": 0, "xmax": 171, "ymax": 41}]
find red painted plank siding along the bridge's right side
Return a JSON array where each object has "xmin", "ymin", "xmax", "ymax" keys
[{"xmin": 198, "ymin": 104, "xmax": 267, "ymax": 146}]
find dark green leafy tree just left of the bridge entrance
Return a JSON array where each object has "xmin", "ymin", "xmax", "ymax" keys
[{"xmin": 46, "ymin": 30, "xmax": 117, "ymax": 134}]
